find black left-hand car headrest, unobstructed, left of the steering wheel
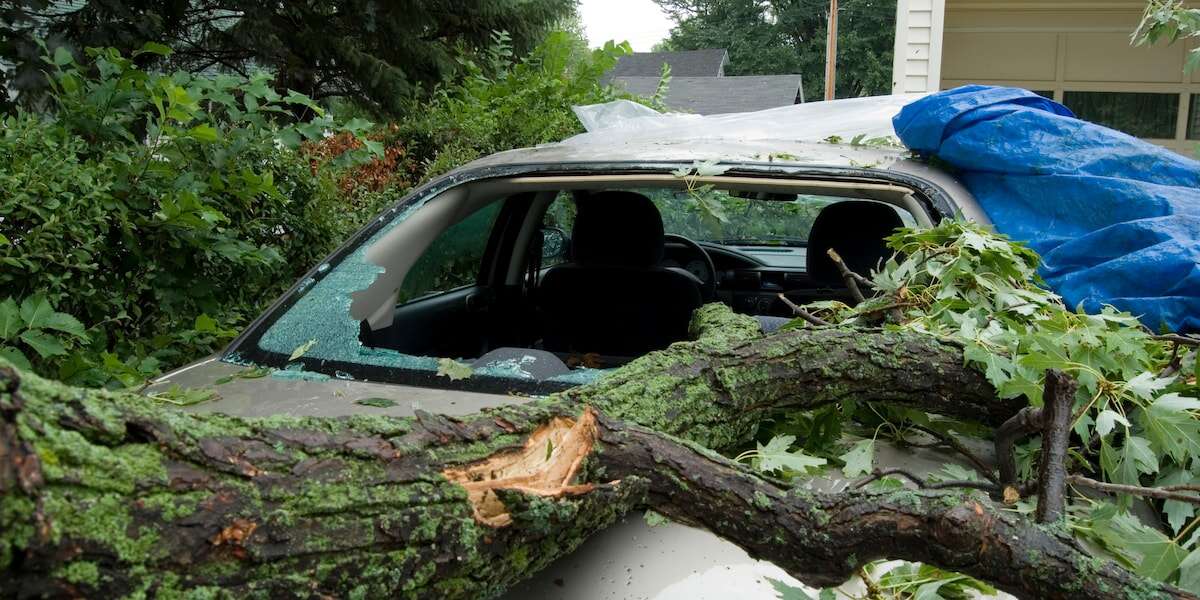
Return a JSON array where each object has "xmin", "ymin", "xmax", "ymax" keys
[{"xmin": 571, "ymin": 192, "xmax": 662, "ymax": 266}]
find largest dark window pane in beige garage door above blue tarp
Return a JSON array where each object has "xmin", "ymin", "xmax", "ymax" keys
[{"xmin": 1063, "ymin": 91, "xmax": 1180, "ymax": 139}]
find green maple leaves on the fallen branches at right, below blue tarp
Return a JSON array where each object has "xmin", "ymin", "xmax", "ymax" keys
[{"xmin": 764, "ymin": 221, "xmax": 1200, "ymax": 590}]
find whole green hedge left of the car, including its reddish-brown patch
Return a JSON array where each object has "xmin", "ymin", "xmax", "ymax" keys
[{"xmin": 0, "ymin": 34, "xmax": 630, "ymax": 385}]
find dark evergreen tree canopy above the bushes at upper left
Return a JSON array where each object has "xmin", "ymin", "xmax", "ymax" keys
[{"xmin": 0, "ymin": 0, "xmax": 575, "ymax": 112}]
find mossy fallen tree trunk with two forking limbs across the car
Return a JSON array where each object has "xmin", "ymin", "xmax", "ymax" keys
[{"xmin": 0, "ymin": 310, "xmax": 1186, "ymax": 598}]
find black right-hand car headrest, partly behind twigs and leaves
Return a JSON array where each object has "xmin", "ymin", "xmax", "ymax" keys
[{"xmin": 808, "ymin": 200, "xmax": 904, "ymax": 287}]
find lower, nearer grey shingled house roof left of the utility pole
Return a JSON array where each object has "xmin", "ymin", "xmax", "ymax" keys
[{"xmin": 613, "ymin": 74, "xmax": 802, "ymax": 114}]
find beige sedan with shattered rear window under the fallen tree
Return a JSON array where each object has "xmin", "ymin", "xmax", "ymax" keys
[{"xmin": 149, "ymin": 98, "xmax": 988, "ymax": 599}]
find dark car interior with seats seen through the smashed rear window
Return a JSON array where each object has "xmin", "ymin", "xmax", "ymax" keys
[{"xmin": 350, "ymin": 175, "xmax": 930, "ymax": 378}]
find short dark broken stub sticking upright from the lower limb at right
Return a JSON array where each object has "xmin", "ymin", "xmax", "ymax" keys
[{"xmin": 1036, "ymin": 368, "xmax": 1078, "ymax": 523}]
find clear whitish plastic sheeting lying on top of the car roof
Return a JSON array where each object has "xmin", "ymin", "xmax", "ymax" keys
[{"xmin": 563, "ymin": 95, "xmax": 918, "ymax": 145}]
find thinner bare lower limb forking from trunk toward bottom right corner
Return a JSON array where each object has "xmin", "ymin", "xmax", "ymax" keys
[{"xmin": 598, "ymin": 416, "xmax": 1192, "ymax": 600}]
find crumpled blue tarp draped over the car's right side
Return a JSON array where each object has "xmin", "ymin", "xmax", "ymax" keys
[{"xmin": 893, "ymin": 85, "xmax": 1200, "ymax": 332}]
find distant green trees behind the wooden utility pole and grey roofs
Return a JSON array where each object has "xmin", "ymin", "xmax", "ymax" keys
[{"xmin": 654, "ymin": 0, "xmax": 896, "ymax": 97}]
